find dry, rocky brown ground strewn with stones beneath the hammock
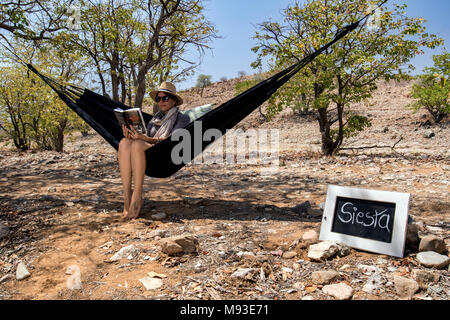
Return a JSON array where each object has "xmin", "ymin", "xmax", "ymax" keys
[{"xmin": 0, "ymin": 80, "xmax": 450, "ymax": 300}]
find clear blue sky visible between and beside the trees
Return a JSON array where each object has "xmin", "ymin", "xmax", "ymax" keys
[{"xmin": 178, "ymin": 0, "xmax": 450, "ymax": 90}]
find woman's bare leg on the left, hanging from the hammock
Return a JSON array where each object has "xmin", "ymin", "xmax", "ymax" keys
[{"xmin": 118, "ymin": 138, "xmax": 133, "ymax": 218}]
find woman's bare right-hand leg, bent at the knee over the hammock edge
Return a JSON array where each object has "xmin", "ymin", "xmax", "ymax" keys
[{"xmin": 128, "ymin": 140, "xmax": 151, "ymax": 219}]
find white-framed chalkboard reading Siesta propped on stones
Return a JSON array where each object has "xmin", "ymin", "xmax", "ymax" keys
[{"xmin": 320, "ymin": 186, "xmax": 410, "ymax": 257}]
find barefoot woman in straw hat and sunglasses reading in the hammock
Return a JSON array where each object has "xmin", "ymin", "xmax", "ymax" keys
[{"xmin": 118, "ymin": 82, "xmax": 190, "ymax": 219}]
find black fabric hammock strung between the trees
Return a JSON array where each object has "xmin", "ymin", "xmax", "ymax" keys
[{"xmin": 27, "ymin": 18, "xmax": 364, "ymax": 178}]
